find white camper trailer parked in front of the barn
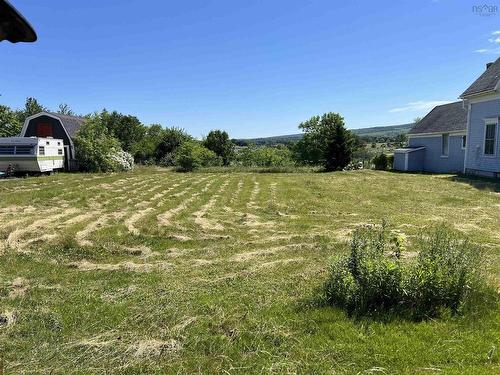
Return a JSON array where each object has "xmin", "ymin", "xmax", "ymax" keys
[{"xmin": 0, "ymin": 137, "xmax": 64, "ymax": 174}]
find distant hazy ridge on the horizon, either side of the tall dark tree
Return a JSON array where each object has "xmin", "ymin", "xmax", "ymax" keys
[{"xmin": 236, "ymin": 124, "xmax": 413, "ymax": 145}]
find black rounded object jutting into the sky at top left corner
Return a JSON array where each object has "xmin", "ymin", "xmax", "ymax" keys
[{"xmin": 0, "ymin": 0, "xmax": 37, "ymax": 43}]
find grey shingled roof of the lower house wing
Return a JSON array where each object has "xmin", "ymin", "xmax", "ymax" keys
[{"xmin": 408, "ymin": 102, "xmax": 467, "ymax": 134}]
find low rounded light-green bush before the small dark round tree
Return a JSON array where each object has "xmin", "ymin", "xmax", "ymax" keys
[{"xmin": 175, "ymin": 141, "xmax": 221, "ymax": 172}]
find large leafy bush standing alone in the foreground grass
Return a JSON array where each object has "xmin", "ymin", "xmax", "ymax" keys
[{"xmin": 324, "ymin": 225, "xmax": 483, "ymax": 319}]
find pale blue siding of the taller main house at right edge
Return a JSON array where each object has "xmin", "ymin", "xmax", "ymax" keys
[{"xmin": 465, "ymin": 99, "xmax": 500, "ymax": 176}]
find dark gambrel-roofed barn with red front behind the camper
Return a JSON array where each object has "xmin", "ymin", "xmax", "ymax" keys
[{"xmin": 20, "ymin": 112, "xmax": 85, "ymax": 171}]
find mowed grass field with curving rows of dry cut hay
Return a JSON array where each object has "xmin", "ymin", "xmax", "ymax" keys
[{"xmin": 0, "ymin": 168, "xmax": 500, "ymax": 374}]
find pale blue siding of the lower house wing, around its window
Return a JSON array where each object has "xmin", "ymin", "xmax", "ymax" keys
[{"xmin": 408, "ymin": 134, "xmax": 465, "ymax": 173}]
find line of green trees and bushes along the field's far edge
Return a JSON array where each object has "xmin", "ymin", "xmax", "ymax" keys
[{"xmin": 0, "ymin": 98, "xmax": 376, "ymax": 171}]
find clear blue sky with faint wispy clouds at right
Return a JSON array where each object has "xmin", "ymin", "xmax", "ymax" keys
[{"xmin": 0, "ymin": 0, "xmax": 500, "ymax": 137}]
